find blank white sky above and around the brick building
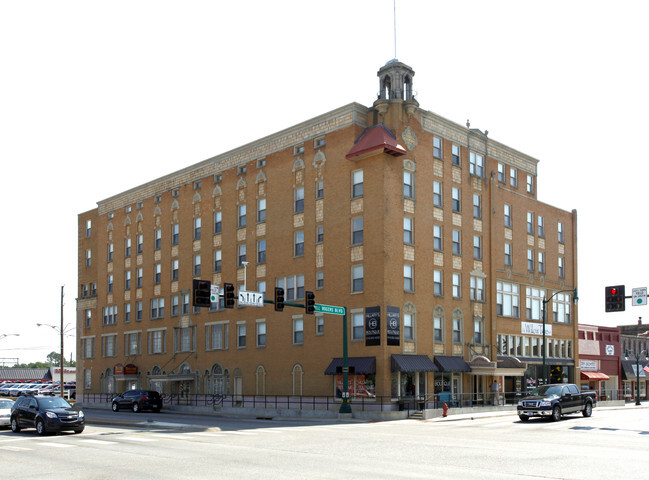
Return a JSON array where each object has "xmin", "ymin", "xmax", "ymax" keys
[{"xmin": 0, "ymin": 0, "xmax": 649, "ymax": 366}]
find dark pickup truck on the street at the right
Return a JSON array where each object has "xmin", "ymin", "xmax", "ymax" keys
[{"xmin": 518, "ymin": 383, "xmax": 597, "ymax": 422}]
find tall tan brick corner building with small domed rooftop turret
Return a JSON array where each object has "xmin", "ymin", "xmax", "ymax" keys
[{"xmin": 77, "ymin": 60, "xmax": 579, "ymax": 402}]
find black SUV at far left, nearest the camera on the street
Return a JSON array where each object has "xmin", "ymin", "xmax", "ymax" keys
[{"xmin": 10, "ymin": 395, "xmax": 86, "ymax": 435}]
